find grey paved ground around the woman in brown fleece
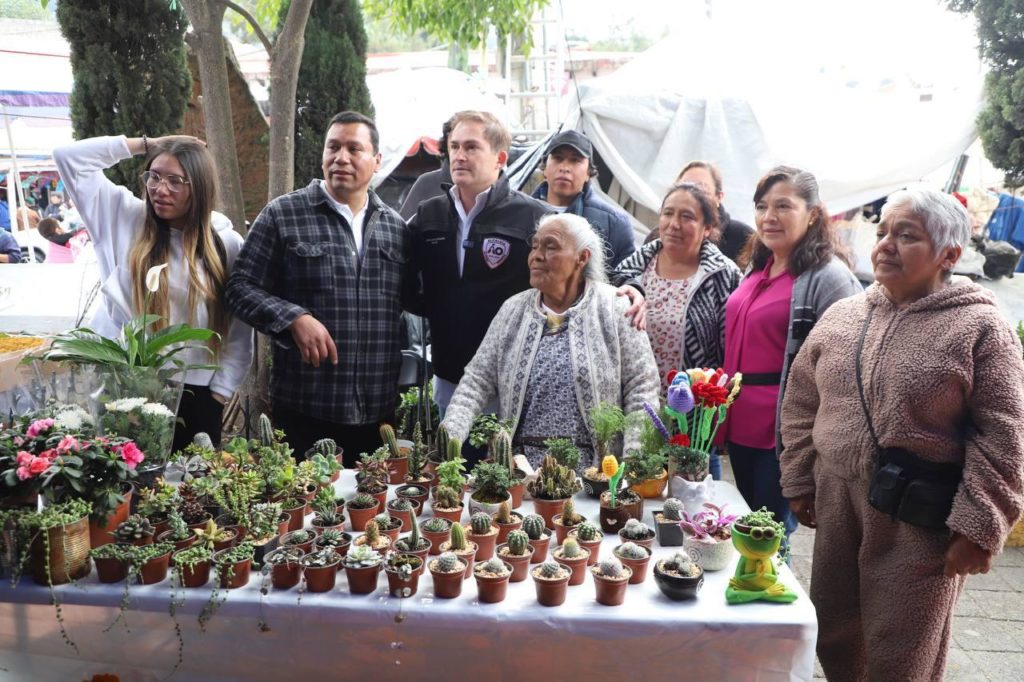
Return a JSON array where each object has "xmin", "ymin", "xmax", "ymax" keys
[{"xmin": 722, "ymin": 454, "xmax": 1024, "ymax": 682}]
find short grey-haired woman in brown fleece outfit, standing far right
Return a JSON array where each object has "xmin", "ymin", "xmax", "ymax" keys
[{"xmin": 781, "ymin": 190, "xmax": 1024, "ymax": 681}]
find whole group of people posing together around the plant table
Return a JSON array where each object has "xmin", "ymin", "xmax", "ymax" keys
[{"xmin": 40, "ymin": 107, "xmax": 1024, "ymax": 679}]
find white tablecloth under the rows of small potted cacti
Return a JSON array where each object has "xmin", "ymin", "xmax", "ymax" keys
[{"xmin": 0, "ymin": 472, "xmax": 817, "ymax": 682}]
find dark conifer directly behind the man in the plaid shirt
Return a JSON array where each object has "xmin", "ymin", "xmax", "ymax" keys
[{"xmin": 281, "ymin": 0, "xmax": 374, "ymax": 187}]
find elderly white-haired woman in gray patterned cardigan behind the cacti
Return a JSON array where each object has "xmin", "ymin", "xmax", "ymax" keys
[{"xmin": 444, "ymin": 214, "xmax": 659, "ymax": 466}]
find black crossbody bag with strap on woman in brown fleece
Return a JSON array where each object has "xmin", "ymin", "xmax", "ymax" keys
[{"xmin": 856, "ymin": 307, "xmax": 964, "ymax": 530}]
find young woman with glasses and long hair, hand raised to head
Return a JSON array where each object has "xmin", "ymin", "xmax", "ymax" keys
[{"xmin": 53, "ymin": 135, "xmax": 252, "ymax": 452}]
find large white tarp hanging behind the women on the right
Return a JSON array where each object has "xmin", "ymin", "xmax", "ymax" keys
[{"xmin": 567, "ymin": 0, "xmax": 984, "ymax": 221}]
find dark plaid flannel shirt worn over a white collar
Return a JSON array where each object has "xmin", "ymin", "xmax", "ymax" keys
[{"xmin": 225, "ymin": 180, "xmax": 412, "ymax": 425}]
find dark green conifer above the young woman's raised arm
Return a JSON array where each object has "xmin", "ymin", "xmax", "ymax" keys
[{"xmin": 56, "ymin": 0, "xmax": 191, "ymax": 189}]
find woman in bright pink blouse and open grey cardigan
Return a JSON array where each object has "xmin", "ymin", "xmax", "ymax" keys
[{"xmin": 722, "ymin": 166, "xmax": 862, "ymax": 534}]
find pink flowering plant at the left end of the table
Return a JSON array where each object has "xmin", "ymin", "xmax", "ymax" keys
[{"xmin": 0, "ymin": 415, "xmax": 145, "ymax": 520}]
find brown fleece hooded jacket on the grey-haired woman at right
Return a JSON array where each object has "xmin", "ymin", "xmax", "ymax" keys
[{"xmin": 780, "ymin": 278, "xmax": 1024, "ymax": 552}]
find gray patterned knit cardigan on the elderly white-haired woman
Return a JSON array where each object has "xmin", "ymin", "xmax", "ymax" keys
[{"xmin": 443, "ymin": 282, "xmax": 660, "ymax": 458}]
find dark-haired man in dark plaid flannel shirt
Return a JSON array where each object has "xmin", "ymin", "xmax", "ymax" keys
[{"xmin": 225, "ymin": 112, "xmax": 412, "ymax": 466}]
